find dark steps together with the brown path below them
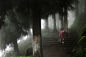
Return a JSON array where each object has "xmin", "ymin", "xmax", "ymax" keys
[{"xmin": 42, "ymin": 31, "xmax": 76, "ymax": 57}]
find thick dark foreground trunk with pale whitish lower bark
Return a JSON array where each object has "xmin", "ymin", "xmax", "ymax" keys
[{"xmin": 33, "ymin": 8, "xmax": 43, "ymax": 57}]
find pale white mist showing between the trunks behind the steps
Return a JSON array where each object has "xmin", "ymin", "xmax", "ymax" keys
[{"xmin": 41, "ymin": 10, "xmax": 75, "ymax": 30}]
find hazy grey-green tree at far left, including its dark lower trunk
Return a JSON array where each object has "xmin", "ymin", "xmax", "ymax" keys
[{"xmin": 1, "ymin": 10, "xmax": 29, "ymax": 55}]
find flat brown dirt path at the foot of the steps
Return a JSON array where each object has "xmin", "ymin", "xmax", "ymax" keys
[{"xmin": 43, "ymin": 43, "xmax": 70, "ymax": 57}]
